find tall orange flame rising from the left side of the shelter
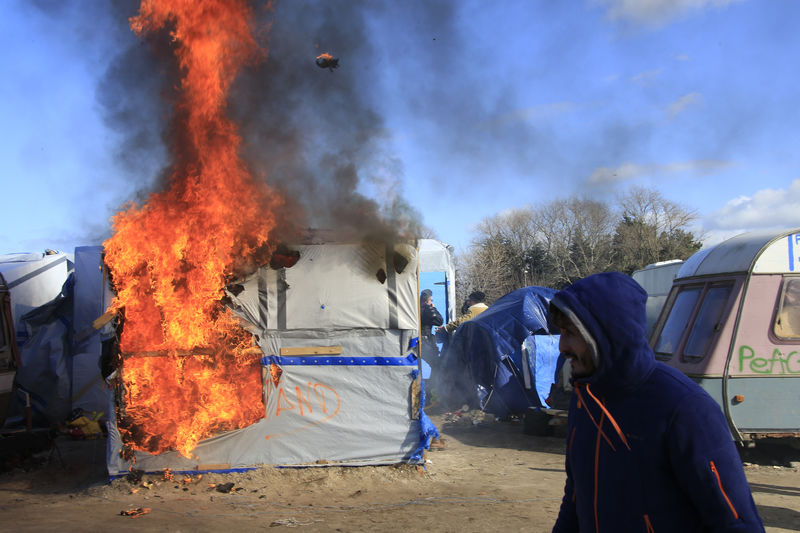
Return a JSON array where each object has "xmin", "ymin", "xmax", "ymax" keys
[{"xmin": 104, "ymin": 0, "xmax": 280, "ymax": 457}]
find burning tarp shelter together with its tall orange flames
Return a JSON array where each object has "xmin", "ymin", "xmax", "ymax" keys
[{"xmin": 103, "ymin": 0, "xmax": 436, "ymax": 476}]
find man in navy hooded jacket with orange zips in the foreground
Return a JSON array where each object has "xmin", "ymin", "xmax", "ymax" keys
[{"xmin": 550, "ymin": 272, "xmax": 764, "ymax": 533}]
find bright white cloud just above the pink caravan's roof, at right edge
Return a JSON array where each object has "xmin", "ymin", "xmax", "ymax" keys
[{"xmin": 703, "ymin": 179, "xmax": 800, "ymax": 232}]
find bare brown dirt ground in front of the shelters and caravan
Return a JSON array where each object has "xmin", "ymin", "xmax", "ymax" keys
[{"xmin": 0, "ymin": 415, "xmax": 800, "ymax": 533}]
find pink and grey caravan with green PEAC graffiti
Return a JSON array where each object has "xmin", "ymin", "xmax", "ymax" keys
[{"xmin": 650, "ymin": 229, "xmax": 800, "ymax": 443}]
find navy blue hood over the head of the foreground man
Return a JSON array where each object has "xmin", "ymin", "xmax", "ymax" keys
[{"xmin": 552, "ymin": 272, "xmax": 655, "ymax": 388}]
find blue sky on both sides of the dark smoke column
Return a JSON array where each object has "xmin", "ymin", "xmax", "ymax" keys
[{"xmin": 0, "ymin": 0, "xmax": 800, "ymax": 253}]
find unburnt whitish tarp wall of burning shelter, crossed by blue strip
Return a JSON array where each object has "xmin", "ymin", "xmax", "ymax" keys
[{"xmin": 108, "ymin": 243, "xmax": 436, "ymax": 477}]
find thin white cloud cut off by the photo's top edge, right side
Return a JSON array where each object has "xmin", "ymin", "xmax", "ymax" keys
[{"xmin": 595, "ymin": 0, "xmax": 742, "ymax": 26}]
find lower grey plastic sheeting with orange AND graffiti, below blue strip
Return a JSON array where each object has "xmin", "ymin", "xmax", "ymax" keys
[{"xmin": 108, "ymin": 358, "xmax": 421, "ymax": 477}]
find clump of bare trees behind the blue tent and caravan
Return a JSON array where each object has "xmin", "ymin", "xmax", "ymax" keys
[{"xmin": 458, "ymin": 187, "xmax": 700, "ymax": 299}]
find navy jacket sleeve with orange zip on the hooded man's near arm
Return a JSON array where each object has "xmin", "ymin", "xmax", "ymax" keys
[{"xmin": 669, "ymin": 395, "xmax": 764, "ymax": 532}]
